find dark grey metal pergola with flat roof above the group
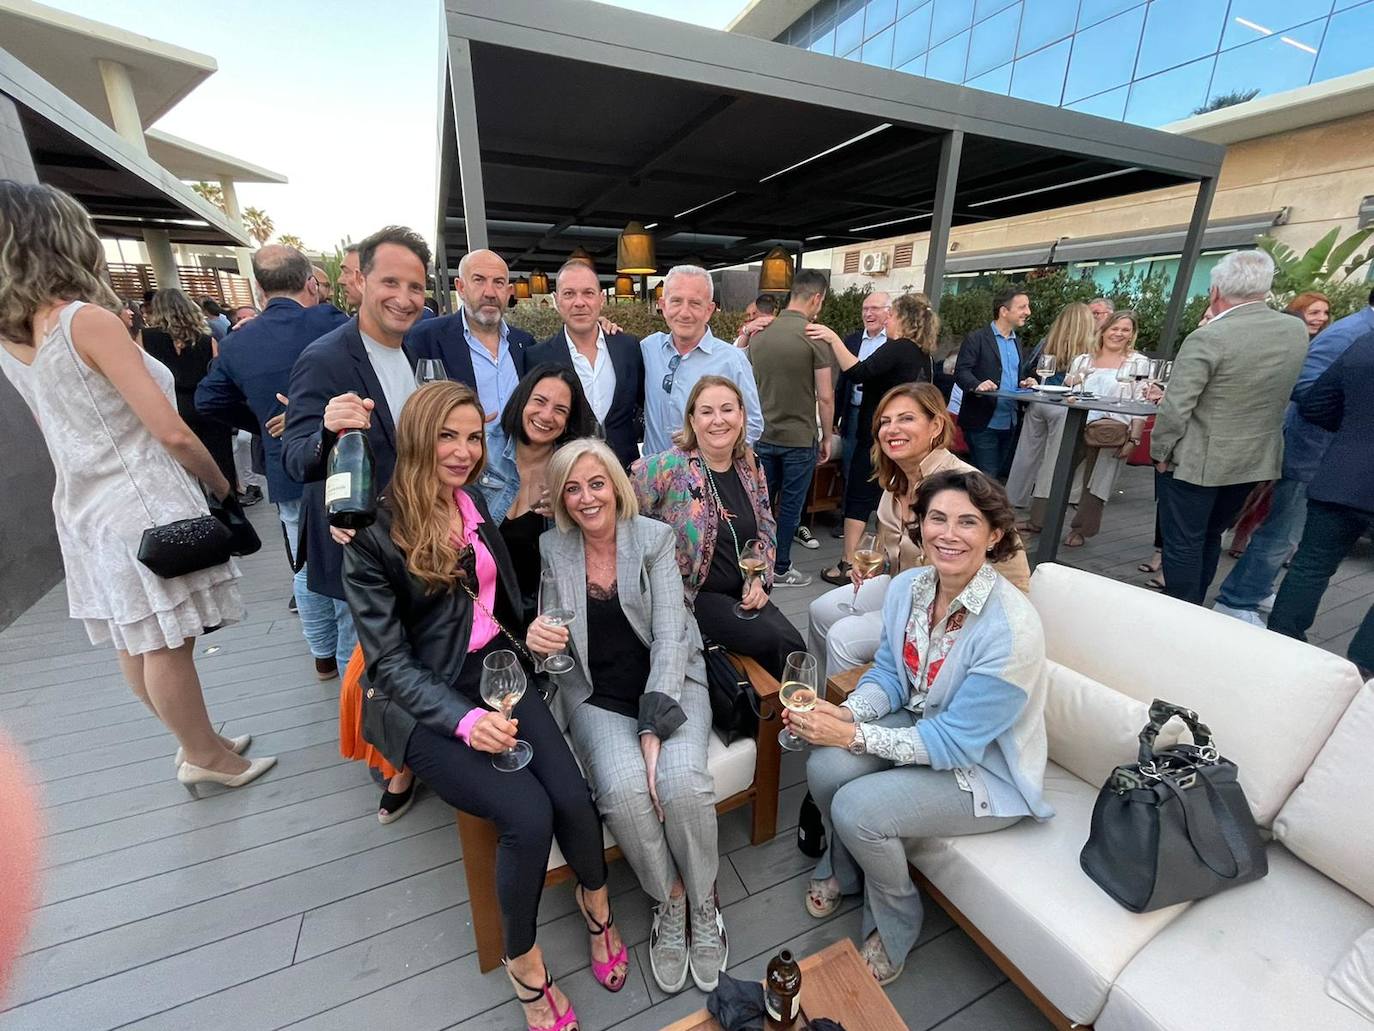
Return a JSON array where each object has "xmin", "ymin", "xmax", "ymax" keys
[{"xmin": 437, "ymin": 0, "xmax": 1224, "ymax": 351}]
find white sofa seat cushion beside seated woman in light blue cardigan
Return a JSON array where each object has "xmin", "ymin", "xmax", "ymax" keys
[{"xmin": 907, "ymin": 763, "xmax": 1186, "ymax": 1024}]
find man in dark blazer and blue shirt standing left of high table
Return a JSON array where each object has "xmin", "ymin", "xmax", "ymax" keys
[{"xmin": 954, "ymin": 287, "xmax": 1031, "ymax": 480}]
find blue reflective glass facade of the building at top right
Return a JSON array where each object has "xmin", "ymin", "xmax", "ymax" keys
[{"xmin": 776, "ymin": 0, "xmax": 1374, "ymax": 126}]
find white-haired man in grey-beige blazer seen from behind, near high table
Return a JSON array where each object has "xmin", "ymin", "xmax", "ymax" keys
[{"xmin": 1150, "ymin": 250, "xmax": 1307, "ymax": 605}]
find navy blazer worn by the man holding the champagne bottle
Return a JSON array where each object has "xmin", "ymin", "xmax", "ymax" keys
[{"xmin": 282, "ymin": 318, "xmax": 415, "ymax": 599}]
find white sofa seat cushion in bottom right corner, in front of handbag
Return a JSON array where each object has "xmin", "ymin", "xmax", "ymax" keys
[{"xmin": 1096, "ymin": 844, "xmax": 1374, "ymax": 1031}]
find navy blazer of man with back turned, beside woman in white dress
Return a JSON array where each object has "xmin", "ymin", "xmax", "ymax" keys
[{"xmin": 195, "ymin": 297, "xmax": 348, "ymax": 503}]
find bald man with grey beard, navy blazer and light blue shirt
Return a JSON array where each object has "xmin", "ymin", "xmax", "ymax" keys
[{"xmin": 405, "ymin": 250, "xmax": 534, "ymax": 450}]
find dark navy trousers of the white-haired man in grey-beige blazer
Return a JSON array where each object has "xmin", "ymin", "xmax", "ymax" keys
[{"xmin": 1156, "ymin": 473, "xmax": 1254, "ymax": 605}]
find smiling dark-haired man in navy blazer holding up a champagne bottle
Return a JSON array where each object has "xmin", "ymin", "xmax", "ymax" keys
[{"xmin": 282, "ymin": 225, "xmax": 430, "ymax": 667}]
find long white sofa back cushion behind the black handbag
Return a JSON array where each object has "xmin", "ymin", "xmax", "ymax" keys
[{"xmin": 1031, "ymin": 564, "xmax": 1360, "ymax": 826}]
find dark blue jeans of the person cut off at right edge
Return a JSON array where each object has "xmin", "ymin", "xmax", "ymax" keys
[{"xmin": 1270, "ymin": 500, "xmax": 1374, "ymax": 679}]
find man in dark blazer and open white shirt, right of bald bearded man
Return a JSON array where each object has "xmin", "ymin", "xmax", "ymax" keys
[{"xmin": 526, "ymin": 261, "xmax": 644, "ymax": 469}]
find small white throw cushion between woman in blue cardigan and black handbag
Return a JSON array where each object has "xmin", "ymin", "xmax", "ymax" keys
[{"xmin": 1044, "ymin": 661, "xmax": 1183, "ymax": 785}]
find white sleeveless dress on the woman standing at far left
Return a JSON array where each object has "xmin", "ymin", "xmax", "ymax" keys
[{"xmin": 0, "ymin": 301, "xmax": 243, "ymax": 654}]
